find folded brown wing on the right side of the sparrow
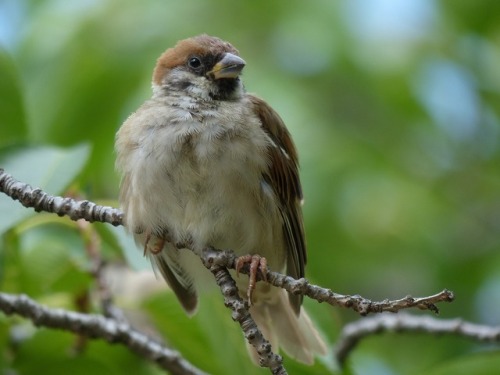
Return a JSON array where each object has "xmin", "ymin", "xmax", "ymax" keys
[{"xmin": 249, "ymin": 95, "xmax": 307, "ymax": 314}]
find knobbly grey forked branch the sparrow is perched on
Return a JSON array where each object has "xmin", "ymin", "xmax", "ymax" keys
[{"xmin": 0, "ymin": 169, "xmax": 454, "ymax": 374}]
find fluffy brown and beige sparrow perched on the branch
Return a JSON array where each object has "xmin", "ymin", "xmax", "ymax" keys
[{"xmin": 115, "ymin": 34, "xmax": 326, "ymax": 364}]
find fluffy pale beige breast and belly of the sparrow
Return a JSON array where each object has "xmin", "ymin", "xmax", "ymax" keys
[{"xmin": 117, "ymin": 95, "xmax": 282, "ymax": 268}]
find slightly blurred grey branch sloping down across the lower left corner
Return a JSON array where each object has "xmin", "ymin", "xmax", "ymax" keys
[{"xmin": 0, "ymin": 293, "xmax": 205, "ymax": 375}]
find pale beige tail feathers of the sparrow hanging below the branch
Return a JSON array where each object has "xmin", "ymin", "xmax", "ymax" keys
[{"xmin": 247, "ymin": 290, "xmax": 327, "ymax": 365}]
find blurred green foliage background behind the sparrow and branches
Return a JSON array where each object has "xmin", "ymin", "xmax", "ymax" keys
[{"xmin": 0, "ymin": 0, "xmax": 500, "ymax": 375}]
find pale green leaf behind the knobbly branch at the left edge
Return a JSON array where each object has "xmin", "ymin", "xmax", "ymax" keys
[{"xmin": 0, "ymin": 144, "xmax": 90, "ymax": 234}]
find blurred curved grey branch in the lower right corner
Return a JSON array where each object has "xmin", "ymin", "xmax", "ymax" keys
[{"xmin": 334, "ymin": 314, "xmax": 500, "ymax": 365}]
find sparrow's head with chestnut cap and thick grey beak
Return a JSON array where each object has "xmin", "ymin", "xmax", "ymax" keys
[{"xmin": 153, "ymin": 34, "xmax": 245, "ymax": 100}]
